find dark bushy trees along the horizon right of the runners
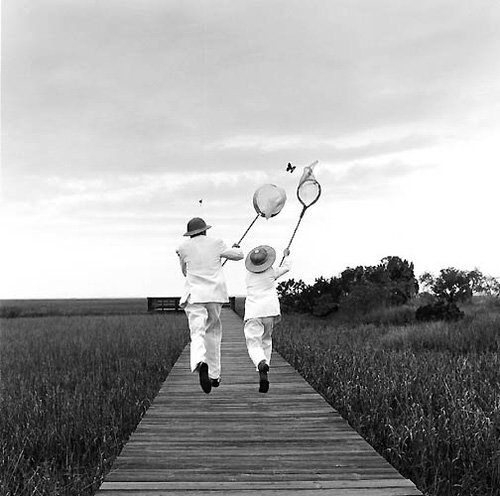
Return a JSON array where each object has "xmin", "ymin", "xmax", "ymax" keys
[{"xmin": 277, "ymin": 256, "xmax": 500, "ymax": 320}]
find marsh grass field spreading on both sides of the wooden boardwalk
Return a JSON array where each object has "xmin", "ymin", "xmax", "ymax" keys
[{"xmin": 0, "ymin": 298, "xmax": 500, "ymax": 496}]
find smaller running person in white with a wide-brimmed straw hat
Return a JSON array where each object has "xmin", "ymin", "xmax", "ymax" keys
[{"xmin": 244, "ymin": 245, "xmax": 290, "ymax": 393}]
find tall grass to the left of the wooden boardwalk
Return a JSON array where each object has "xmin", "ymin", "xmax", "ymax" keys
[{"xmin": 0, "ymin": 314, "xmax": 188, "ymax": 496}]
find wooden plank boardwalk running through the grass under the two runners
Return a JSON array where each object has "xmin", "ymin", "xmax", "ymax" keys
[{"xmin": 97, "ymin": 309, "xmax": 422, "ymax": 496}]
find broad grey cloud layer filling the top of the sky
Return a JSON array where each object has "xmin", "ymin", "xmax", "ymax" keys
[{"xmin": 3, "ymin": 0, "xmax": 498, "ymax": 175}]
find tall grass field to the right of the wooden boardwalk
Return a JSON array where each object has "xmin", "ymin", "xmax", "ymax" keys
[{"xmin": 274, "ymin": 301, "xmax": 500, "ymax": 496}]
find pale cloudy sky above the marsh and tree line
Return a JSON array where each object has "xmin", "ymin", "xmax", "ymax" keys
[{"xmin": 0, "ymin": 0, "xmax": 500, "ymax": 299}]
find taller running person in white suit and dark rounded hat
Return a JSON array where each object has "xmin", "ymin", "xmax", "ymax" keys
[{"xmin": 177, "ymin": 217, "xmax": 243, "ymax": 394}]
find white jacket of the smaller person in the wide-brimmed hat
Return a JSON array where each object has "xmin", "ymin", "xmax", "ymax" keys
[{"xmin": 244, "ymin": 259, "xmax": 290, "ymax": 320}]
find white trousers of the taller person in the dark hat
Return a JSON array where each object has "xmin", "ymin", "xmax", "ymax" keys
[{"xmin": 184, "ymin": 302, "xmax": 222, "ymax": 379}]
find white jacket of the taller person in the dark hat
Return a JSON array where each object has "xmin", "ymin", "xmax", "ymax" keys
[{"xmin": 177, "ymin": 235, "xmax": 243, "ymax": 305}]
